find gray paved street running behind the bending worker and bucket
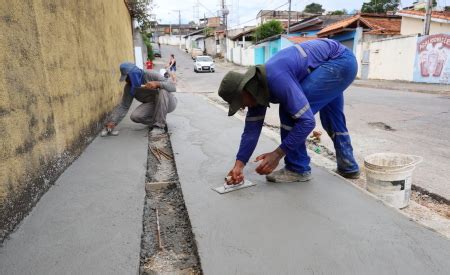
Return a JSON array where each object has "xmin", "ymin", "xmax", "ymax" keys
[{"xmin": 163, "ymin": 46, "xmax": 450, "ymax": 200}]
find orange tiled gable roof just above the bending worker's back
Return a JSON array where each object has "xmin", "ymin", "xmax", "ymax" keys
[{"xmin": 317, "ymin": 14, "xmax": 401, "ymax": 37}]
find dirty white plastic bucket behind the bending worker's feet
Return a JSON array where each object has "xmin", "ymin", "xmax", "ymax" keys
[{"xmin": 364, "ymin": 153, "xmax": 423, "ymax": 208}]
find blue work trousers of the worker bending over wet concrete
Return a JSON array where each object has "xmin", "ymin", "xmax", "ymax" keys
[{"xmin": 279, "ymin": 50, "xmax": 359, "ymax": 173}]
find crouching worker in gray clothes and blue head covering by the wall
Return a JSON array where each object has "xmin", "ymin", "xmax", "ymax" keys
[{"xmin": 101, "ymin": 62, "xmax": 177, "ymax": 136}]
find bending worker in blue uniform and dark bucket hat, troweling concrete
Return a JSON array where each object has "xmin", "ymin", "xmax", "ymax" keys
[{"xmin": 219, "ymin": 39, "xmax": 360, "ymax": 184}]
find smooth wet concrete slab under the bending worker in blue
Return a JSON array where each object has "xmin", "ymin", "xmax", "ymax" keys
[{"xmin": 169, "ymin": 94, "xmax": 450, "ymax": 274}]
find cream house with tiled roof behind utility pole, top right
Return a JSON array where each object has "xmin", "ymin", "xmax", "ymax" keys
[{"xmin": 397, "ymin": 10, "xmax": 450, "ymax": 35}]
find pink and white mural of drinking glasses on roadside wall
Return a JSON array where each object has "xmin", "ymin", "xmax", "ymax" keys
[{"xmin": 414, "ymin": 34, "xmax": 450, "ymax": 84}]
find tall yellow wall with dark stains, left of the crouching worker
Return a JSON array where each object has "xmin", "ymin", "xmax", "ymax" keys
[{"xmin": 0, "ymin": 0, "xmax": 134, "ymax": 242}]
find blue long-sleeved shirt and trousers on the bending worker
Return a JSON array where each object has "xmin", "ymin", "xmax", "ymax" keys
[{"xmin": 236, "ymin": 39, "xmax": 359, "ymax": 173}]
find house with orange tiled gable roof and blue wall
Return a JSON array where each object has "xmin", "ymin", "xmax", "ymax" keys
[{"xmin": 317, "ymin": 13, "xmax": 401, "ymax": 51}]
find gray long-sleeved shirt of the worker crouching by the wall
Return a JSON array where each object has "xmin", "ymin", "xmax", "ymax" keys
[{"xmin": 109, "ymin": 70, "xmax": 176, "ymax": 124}]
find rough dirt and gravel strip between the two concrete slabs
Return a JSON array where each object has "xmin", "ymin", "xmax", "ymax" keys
[{"xmin": 140, "ymin": 133, "xmax": 202, "ymax": 274}]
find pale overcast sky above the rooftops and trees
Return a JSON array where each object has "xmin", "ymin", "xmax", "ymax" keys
[{"xmin": 152, "ymin": 0, "xmax": 442, "ymax": 27}]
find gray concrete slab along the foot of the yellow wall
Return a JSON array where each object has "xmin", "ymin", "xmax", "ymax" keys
[{"xmin": 0, "ymin": 106, "xmax": 148, "ymax": 274}]
